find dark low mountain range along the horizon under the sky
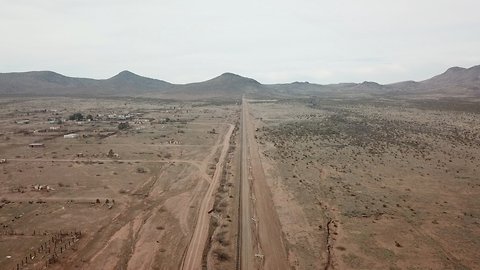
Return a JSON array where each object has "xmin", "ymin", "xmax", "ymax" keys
[{"xmin": 0, "ymin": 65, "xmax": 480, "ymax": 99}]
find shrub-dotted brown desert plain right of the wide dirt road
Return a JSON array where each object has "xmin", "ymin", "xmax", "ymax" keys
[{"xmin": 250, "ymin": 98, "xmax": 480, "ymax": 269}]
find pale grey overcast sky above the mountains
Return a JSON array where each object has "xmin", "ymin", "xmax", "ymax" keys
[{"xmin": 0, "ymin": 0, "xmax": 480, "ymax": 83}]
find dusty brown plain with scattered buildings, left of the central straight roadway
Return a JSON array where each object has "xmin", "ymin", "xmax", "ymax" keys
[{"xmin": 0, "ymin": 98, "xmax": 239, "ymax": 269}]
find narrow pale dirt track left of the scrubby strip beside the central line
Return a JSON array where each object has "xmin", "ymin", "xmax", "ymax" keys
[{"xmin": 182, "ymin": 125, "xmax": 234, "ymax": 269}]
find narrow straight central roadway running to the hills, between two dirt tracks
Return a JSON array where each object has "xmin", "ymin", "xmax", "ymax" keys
[{"xmin": 238, "ymin": 98, "xmax": 253, "ymax": 270}]
